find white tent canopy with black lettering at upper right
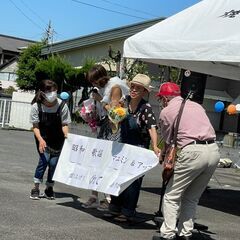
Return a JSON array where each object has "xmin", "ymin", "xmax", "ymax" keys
[{"xmin": 123, "ymin": 0, "xmax": 240, "ymax": 80}]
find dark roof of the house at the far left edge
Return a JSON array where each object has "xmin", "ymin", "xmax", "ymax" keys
[{"xmin": 0, "ymin": 34, "xmax": 35, "ymax": 52}]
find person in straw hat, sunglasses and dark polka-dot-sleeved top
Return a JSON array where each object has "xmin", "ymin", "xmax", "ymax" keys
[{"xmin": 109, "ymin": 74, "xmax": 160, "ymax": 221}]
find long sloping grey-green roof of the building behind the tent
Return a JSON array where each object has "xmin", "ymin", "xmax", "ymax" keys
[{"xmin": 42, "ymin": 18, "xmax": 164, "ymax": 55}]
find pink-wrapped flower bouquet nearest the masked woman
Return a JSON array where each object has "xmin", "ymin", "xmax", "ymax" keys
[{"xmin": 79, "ymin": 98, "xmax": 98, "ymax": 132}]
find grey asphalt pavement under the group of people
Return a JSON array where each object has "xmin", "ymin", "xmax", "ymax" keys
[{"xmin": 0, "ymin": 130, "xmax": 240, "ymax": 240}]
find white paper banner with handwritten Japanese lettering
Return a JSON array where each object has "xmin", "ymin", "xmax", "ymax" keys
[{"xmin": 53, "ymin": 134, "xmax": 158, "ymax": 196}]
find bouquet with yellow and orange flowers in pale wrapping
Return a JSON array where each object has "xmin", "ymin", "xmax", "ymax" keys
[{"xmin": 108, "ymin": 106, "xmax": 127, "ymax": 133}]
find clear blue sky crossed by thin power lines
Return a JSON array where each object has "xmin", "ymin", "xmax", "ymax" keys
[{"xmin": 0, "ymin": 0, "xmax": 200, "ymax": 42}]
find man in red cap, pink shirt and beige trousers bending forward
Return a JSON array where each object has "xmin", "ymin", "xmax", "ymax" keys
[{"xmin": 157, "ymin": 82, "xmax": 220, "ymax": 240}]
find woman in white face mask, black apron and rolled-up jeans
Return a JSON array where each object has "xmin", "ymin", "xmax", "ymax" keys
[{"xmin": 30, "ymin": 80, "xmax": 71, "ymax": 199}]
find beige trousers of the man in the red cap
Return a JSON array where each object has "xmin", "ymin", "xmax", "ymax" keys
[{"xmin": 160, "ymin": 143, "xmax": 220, "ymax": 238}]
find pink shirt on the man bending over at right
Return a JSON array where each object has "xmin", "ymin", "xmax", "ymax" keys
[{"xmin": 160, "ymin": 97, "xmax": 216, "ymax": 148}]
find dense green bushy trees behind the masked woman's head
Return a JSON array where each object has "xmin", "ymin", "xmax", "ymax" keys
[{"xmin": 17, "ymin": 43, "xmax": 94, "ymax": 93}]
